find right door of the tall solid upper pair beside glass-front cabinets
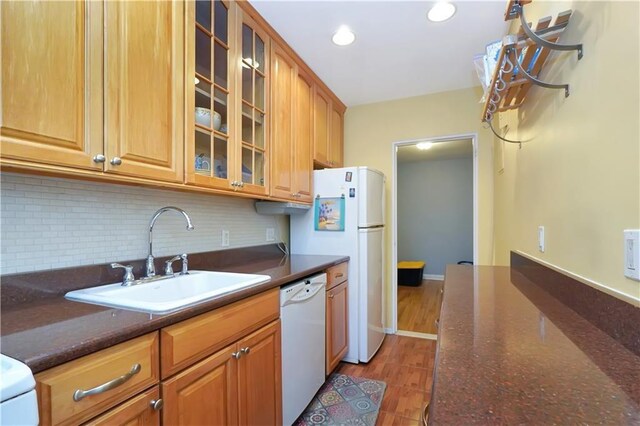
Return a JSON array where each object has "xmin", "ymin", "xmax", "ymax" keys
[{"xmin": 293, "ymin": 70, "xmax": 313, "ymax": 203}]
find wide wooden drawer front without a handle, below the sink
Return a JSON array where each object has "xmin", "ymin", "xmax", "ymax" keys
[{"xmin": 160, "ymin": 288, "xmax": 280, "ymax": 379}]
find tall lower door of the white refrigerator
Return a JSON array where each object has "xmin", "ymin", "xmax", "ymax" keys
[{"xmin": 358, "ymin": 227, "xmax": 384, "ymax": 362}]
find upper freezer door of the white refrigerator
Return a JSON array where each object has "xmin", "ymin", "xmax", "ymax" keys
[{"xmin": 357, "ymin": 167, "xmax": 385, "ymax": 228}]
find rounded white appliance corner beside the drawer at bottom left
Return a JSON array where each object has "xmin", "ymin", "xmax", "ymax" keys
[{"xmin": 0, "ymin": 355, "xmax": 38, "ymax": 426}]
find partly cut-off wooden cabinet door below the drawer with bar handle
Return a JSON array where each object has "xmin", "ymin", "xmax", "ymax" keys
[{"xmin": 86, "ymin": 386, "xmax": 160, "ymax": 426}]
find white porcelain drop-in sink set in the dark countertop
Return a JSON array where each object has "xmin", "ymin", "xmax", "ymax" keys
[{"xmin": 65, "ymin": 271, "xmax": 271, "ymax": 314}]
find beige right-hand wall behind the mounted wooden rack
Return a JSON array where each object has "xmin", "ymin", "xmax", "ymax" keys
[{"xmin": 494, "ymin": 1, "xmax": 640, "ymax": 300}]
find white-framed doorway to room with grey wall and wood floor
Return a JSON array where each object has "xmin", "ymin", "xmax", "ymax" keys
[{"xmin": 389, "ymin": 134, "xmax": 478, "ymax": 339}]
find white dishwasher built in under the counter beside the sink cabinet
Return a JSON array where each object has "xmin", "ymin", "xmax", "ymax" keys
[{"xmin": 280, "ymin": 274, "xmax": 327, "ymax": 425}]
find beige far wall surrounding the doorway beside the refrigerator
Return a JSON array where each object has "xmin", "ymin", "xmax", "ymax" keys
[{"xmin": 344, "ymin": 87, "xmax": 493, "ymax": 327}]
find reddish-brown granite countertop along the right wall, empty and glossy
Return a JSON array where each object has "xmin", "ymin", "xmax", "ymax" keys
[{"xmin": 429, "ymin": 265, "xmax": 640, "ymax": 426}]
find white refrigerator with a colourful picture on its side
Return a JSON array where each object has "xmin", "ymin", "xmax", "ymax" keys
[{"xmin": 290, "ymin": 167, "xmax": 385, "ymax": 363}]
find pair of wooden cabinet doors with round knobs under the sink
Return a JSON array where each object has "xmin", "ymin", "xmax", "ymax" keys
[{"xmin": 162, "ymin": 320, "xmax": 282, "ymax": 425}]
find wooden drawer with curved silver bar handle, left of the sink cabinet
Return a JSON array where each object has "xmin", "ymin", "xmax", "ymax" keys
[{"xmin": 36, "ymin": 333, "xmax": 160, "ymax": 425}]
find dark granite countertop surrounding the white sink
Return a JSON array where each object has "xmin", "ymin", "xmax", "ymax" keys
[{"xmin": 0, "ymin": 248, "xmax": 349, "ymax": 373}]
